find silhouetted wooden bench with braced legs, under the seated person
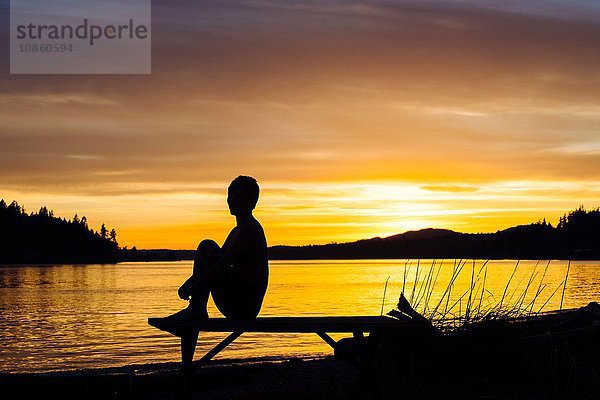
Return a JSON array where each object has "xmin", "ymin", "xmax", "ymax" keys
[{"xmin": 148, "ymin": 316, "xmax": 423, "ymax": 398}]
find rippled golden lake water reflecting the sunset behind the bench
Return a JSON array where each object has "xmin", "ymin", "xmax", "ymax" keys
[{"xmin": 0, "ymin": 260, "xmax": 600, "ymax": 372}]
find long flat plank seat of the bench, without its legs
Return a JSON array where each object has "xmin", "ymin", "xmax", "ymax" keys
[{"xmin": 148, "ymin": 316, "xmax": 421, "ymax": 333}]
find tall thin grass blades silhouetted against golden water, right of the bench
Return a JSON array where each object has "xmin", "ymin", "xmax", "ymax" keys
[{"xmin": 394, "ymin": 259, "xmax": 571, "ymax": 331}]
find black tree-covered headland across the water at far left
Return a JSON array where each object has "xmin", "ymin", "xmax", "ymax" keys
[{"xmin": 0, "ymin": 200, "xmax": 119, "ymax": 264}]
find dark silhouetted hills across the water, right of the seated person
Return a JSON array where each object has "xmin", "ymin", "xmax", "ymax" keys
[{"xmin": 269, "ymin": 207, "xmax": 600, "ymax": 260}]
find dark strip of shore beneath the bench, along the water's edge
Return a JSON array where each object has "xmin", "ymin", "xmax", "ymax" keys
[{"xmin": 0, "ymin": 357, "xmax": 357, "ymax": 400}]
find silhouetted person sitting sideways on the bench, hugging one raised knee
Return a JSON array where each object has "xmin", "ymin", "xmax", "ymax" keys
[{"xmin": 168, "ymin": 175, "xmax": 269, "ymax": 328}]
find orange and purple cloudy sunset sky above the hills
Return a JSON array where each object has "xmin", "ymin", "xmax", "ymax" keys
[{"xmin": 0, "ymin": 0, "xmax": 600, "ymax": 248}]
